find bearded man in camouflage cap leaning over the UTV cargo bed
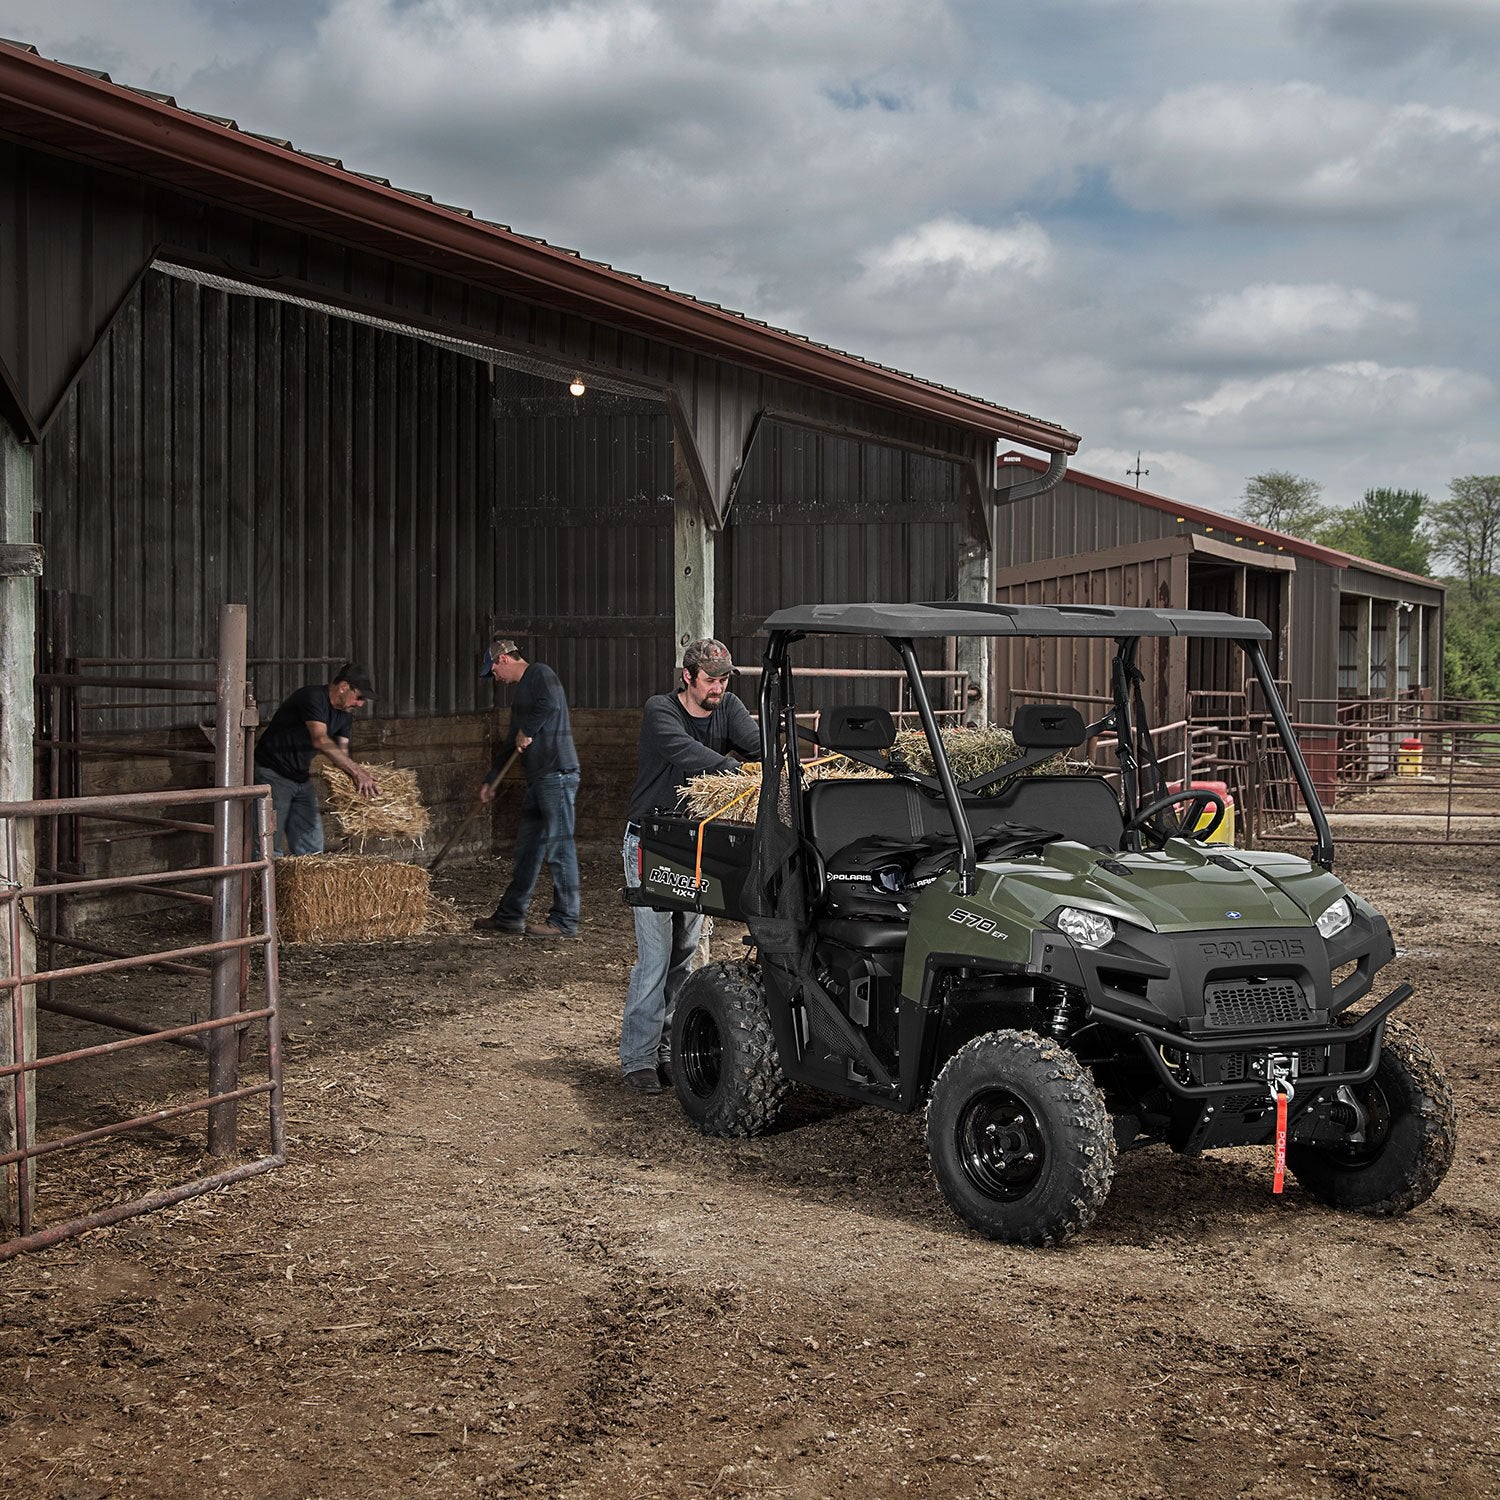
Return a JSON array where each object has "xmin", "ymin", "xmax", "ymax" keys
[{"xmin": 620, "ymin": 641, "xmax": 761, "ymax": 1094}]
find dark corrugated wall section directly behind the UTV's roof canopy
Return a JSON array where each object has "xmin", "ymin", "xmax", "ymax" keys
[{"xmin": 723, "ymin": 423, "xmax": 963, "ymax": 707}]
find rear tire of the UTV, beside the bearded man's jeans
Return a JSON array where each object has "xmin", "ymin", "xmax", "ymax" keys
[{"xmin": 672, "ymin": 963, "xmax": 792, "ymax": 1136}]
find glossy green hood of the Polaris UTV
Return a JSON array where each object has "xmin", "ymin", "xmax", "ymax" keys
[{"xmin": 905, "ymin": 839, "xmax": 1364, "ymax": 993}]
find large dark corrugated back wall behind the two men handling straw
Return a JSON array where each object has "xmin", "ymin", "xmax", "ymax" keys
[{"xmin": 38, "ymin": 275, "xmax": 672, "ymax": 728}]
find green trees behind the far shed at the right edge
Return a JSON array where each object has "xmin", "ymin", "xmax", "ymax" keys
[{"xmin": 1241, "ymin": 470, "xmax": 1500, "ymax": 699}]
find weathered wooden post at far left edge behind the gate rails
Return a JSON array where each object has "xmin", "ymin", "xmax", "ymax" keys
[{"xmin": 0, "ymin": 423, "xmax": 36, "ymax": 1227}]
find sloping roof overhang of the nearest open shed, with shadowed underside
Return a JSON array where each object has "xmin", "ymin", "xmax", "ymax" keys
[{"xmin": 0, "ymin": 44, "xmax": 1079, "ymax": 455}]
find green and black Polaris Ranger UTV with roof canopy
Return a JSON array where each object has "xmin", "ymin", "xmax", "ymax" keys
[{"xmin": 627, "ymin": 605, "xmax": 1455, "ymax": 1245}]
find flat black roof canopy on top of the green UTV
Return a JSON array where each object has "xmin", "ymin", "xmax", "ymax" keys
[{"xmin": 765, "ymin": 603, "xmax": 1271, "ymax": 641}]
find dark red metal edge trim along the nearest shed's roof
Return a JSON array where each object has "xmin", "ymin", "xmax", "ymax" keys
[{"xmin": 0, "ymin": 39, "xmax": 1079, "ymax": 453}]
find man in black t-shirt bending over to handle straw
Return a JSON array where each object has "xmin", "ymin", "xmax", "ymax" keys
[{"xmin": 255, "ymin": 662, "xmax": 380, "ymax": 854}]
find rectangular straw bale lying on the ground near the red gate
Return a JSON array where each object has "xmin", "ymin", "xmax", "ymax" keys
[{"xmin": 275, "ymin": 854, "xmax": 455, "ymax": 942}]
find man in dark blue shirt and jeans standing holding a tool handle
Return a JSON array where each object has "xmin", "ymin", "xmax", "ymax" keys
[{"xmin": 474, "ymin": 636, "xmax": 581, "ymax": 938}]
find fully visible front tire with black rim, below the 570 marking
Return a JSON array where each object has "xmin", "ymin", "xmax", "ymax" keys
[{"xmin": 927, "ymin": 1031, "xmax": 1115, "ymax": 1245}]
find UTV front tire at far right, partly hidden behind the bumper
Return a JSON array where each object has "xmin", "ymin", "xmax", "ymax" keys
[{"xmin": 1287, "ymin": 1022, "xmax": 1458, "ymax": 1218}]
